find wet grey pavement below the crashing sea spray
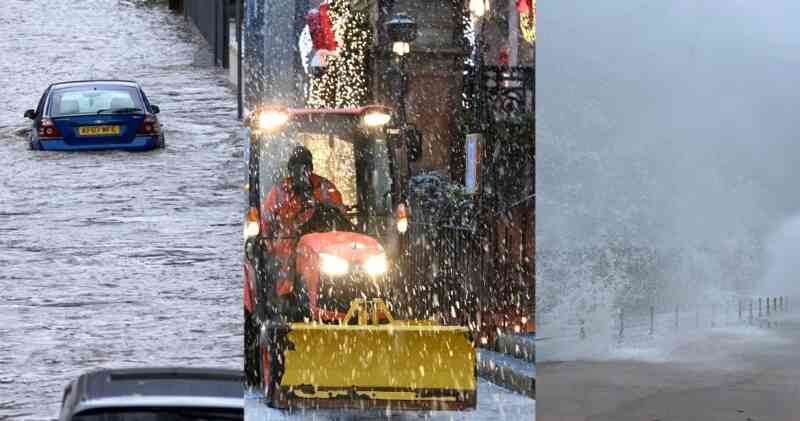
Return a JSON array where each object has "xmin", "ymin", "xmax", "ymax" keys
[{"xmin": 537, "ymin": 314, "xmax": 800, "ymax": 421}]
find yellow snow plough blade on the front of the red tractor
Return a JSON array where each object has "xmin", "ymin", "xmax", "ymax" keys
[{"xmin": 262, "ymin": 299, "xmax": 476, "ymax": 410}]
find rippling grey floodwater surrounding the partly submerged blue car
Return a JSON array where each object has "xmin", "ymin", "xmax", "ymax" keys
[{"xmin": 0, "ymin": 0, "xmax": 244, "ymax": 420}]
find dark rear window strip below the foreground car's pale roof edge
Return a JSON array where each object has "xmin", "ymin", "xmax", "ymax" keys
[{"xmin": 71, "ymin": 407, "xmax": 244, "ymax": 421}]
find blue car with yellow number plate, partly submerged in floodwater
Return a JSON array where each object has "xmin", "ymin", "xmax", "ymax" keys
[{"xmin": 25, "ymin": 80, "xmax": 164, "ymax": 151}]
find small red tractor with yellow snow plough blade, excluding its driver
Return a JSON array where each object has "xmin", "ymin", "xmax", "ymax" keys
[{"xmin": 244, "ymin": 106, "xmax": 477, "ymax": 410}]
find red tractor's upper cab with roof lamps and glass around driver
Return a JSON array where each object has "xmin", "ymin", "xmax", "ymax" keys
[{"xmin": 251, "ymin": 107, "xmax": 396, "ymax": 243}]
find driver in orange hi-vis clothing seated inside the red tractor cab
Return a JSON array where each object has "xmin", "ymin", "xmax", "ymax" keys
[{"xmin": 261, "ymin": 146, "xmax": 344, "ymax": 296}]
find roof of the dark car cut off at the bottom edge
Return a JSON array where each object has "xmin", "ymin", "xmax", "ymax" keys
[{"xmin": 62, "ymin": 367, "xmax": 244, "ymax": 419}]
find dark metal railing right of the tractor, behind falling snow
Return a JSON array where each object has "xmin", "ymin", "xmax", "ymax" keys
[{"xmin": 400, "ymin": 202, "xmax": 535, "ymax": 343}]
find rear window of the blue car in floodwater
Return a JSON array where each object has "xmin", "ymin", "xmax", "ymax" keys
[{"xmin": 48, "ymin": 85, "xmax": 145, "ymax": 117}]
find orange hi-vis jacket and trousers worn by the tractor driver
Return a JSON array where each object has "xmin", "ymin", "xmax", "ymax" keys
[{"xmin": 261, "ymin": 174, "xmax": 344, "ymax": 295}]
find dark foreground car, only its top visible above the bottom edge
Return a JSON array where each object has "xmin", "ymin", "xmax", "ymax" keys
[{"xmin": 59, "ymin": 368, "xmax": 244, "ymax": 421}]
